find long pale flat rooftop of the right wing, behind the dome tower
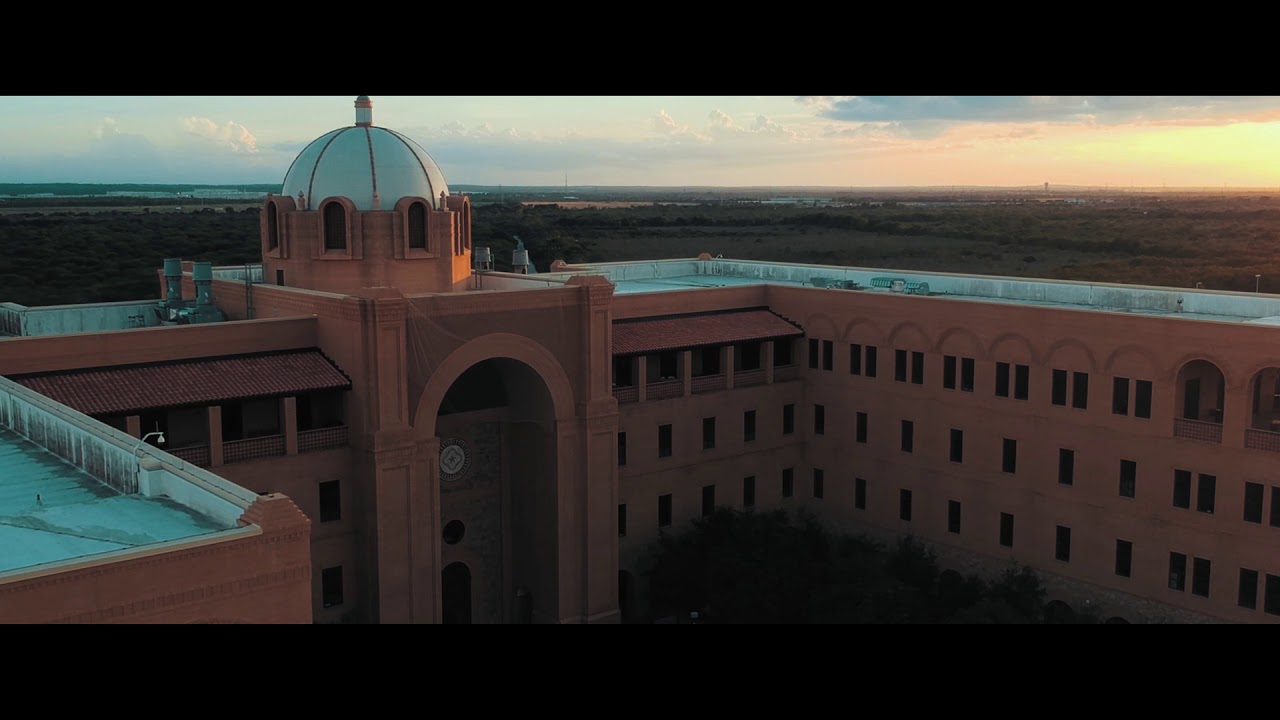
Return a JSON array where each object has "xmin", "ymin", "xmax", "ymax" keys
[{"xmin": 565, "ymin": 258, "xmax": 1280, "ymax": 325}]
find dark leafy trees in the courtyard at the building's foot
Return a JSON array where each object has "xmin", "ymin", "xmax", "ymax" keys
[{"xmin": 649, "ymin": 507, "xmax": 1101, "ymax": 624}]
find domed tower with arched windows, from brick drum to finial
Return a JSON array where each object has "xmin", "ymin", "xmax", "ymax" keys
[{"xmin": 261, "ymin": 95, "xmax": 471, "ymax": 293}]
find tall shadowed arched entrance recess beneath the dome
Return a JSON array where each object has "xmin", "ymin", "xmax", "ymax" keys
[{"xmin": 435, "ymin": 357, "xmax": 559, "ymax": 623}]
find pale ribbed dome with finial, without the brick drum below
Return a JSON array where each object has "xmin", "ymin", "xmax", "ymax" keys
[{"xmin": 280, "ymin": 95, "xmax": 449, "ymax": 210}]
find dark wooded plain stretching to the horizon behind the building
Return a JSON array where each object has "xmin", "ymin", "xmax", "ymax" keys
[{"xmin": 0, "ymin": 186, "xmax": 1280, "ymax": 305}]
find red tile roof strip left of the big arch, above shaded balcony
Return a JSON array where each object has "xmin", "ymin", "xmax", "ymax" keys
[{"xmin": 12, "ymin": 350, "xmax": 351, "ymax": 415}]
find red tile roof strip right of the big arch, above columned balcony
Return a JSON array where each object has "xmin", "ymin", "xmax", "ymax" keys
[{"xmin": 613, "ymin": 310, "xmax": 804, "ymax": 355}]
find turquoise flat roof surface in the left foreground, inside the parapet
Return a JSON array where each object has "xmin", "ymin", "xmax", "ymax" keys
[{"xmin": 0, "ymin": 425, "xmax": 234, "ymax": 573}]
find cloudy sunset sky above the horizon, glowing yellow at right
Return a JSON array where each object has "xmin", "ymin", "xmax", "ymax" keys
[{"xmin": 0, "ymin": 95, "xmax": 1280, "ymax": 188}]
